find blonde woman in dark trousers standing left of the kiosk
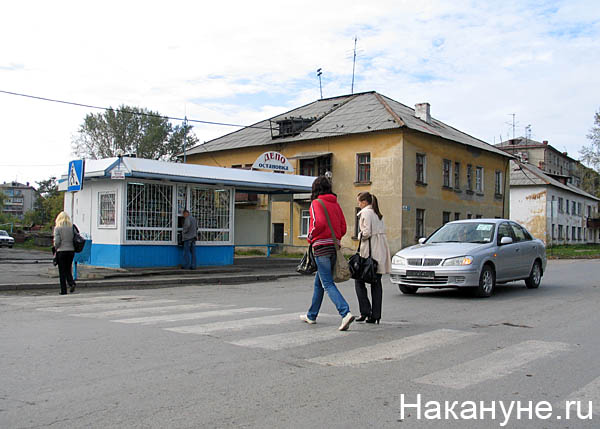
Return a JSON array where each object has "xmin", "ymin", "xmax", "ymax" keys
[{"xmin": 54, "ymin": 212, "xmax": 75, "ymax": 295}]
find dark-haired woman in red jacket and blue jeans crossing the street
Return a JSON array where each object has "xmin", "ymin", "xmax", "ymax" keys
[{"xmin": 300, "ymin": 176, "xmax": 354, "ymax": 331}]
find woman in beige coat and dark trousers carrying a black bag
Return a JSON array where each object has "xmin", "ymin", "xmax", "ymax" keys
[{"xmin": 354, "ymin": 192, "xmax": 392, "ymax": 324}]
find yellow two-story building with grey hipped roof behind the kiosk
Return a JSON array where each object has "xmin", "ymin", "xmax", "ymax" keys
[{"xmin": 187, "ymin": 92, "xmax": 512, "ymax": 251}]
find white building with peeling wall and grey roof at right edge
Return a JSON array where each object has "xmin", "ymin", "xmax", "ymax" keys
[{"xmin": 510, "ymin": 161, "xmax": 600, "ymax": 245}]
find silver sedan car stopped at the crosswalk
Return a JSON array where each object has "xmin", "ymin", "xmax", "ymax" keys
[{"xmin": 390, "ymin": 219, "xmax": 546, "ymax": 297}]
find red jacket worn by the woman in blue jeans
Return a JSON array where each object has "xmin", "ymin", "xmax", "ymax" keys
[{"xmin": 308, "ymin": 194, "xmax": 346, "ymax": 247}]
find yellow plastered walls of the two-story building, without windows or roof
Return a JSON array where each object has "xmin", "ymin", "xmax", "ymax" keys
[{"xmin": 188, "ymin": 130, "xmax": 509, "ymax": 253}]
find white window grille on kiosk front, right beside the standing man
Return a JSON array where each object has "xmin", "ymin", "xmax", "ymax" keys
[{"xmin": 190, "ymin": 188, "xmax": 232, "ymax": 242}]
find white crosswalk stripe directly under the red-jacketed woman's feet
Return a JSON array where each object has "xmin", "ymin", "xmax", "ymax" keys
[{"xmin": 229, "ymin": 327, "xmax": 343, "ymax": 350}]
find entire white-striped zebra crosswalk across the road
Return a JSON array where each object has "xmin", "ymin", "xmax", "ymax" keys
[{"xmin": 0, "ymin": 294, "xmax": 600, "ymax": 401}]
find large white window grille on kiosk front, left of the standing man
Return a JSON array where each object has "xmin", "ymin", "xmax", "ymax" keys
[{"xmin": 125, "ymin": 183, "xmax": 173, "ymax": 242}]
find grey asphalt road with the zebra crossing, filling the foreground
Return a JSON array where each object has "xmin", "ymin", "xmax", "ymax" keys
[{"xmin": 0, "ymin": 260, "xmax": 600, "ymax": 428}]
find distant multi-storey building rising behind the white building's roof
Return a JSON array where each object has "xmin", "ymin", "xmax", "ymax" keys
[{"xmin": 496, "ymin": 137, "xmax": 581, "ymax": 188}]
